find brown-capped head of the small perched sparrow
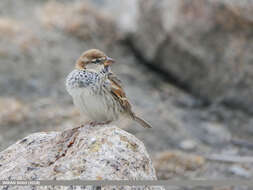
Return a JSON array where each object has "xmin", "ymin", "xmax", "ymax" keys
[{"xmin": 76, "ymin": 49, "xmax": 114, "ymax": 71}]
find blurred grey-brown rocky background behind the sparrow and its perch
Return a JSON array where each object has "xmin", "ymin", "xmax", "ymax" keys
[{"xmin": 0, "ymin": 0, "xmax": 253, "ymax": 189}]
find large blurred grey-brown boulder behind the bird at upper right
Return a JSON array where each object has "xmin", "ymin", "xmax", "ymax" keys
[{"xmin": 130, "ymin": 0, "xmax": 253, "ymax": 112}]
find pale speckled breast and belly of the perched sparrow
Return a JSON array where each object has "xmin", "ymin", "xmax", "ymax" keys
[{"xmin": 66, "ymin": 69, "xmax": 119, "ymax": 121}]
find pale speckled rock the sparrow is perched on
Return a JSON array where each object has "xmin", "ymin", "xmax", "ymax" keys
[{"xmin": 0, "ymin": 125, "xmax": 163, "ymax": 189}]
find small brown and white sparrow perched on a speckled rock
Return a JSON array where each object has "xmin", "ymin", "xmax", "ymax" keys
[{"xmin": 66, "ymin": 49, "xmax": 151, "ymax": 128}]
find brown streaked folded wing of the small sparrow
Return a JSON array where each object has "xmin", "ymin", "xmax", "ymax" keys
[{"xmin": 108, "ymin": 73, "xmax": 133, "ymax": 115}]
